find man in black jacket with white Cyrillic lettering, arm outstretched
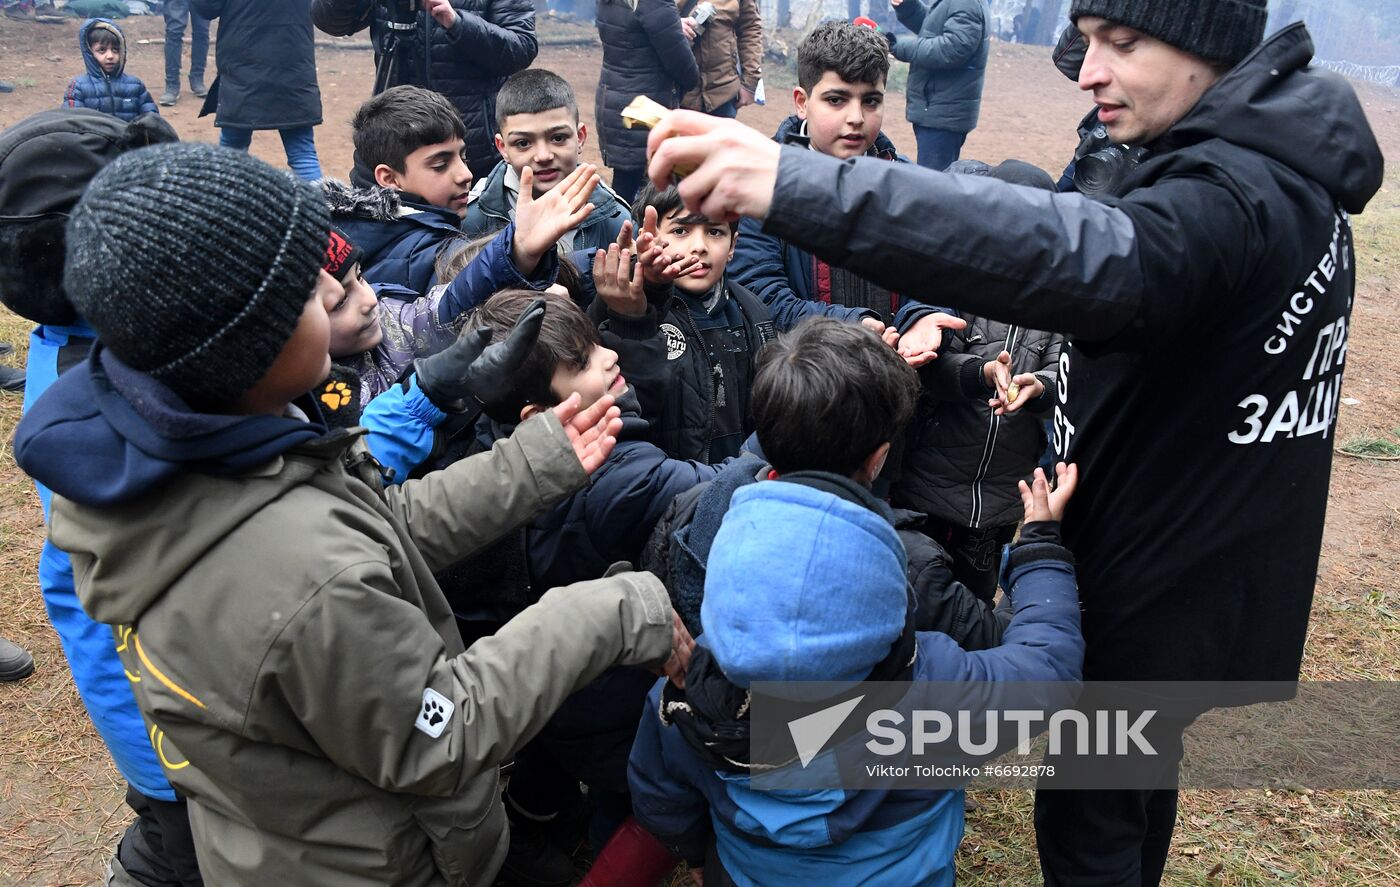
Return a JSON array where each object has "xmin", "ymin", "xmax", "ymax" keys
[{"xmin": 650, "ymin": 0, "xmax": 1383, "ymax": 886}]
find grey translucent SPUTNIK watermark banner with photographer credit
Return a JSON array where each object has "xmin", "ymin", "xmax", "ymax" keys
[{"xmin": 749, "ymin": 681, "xmax": 1400, "ymax": 790}]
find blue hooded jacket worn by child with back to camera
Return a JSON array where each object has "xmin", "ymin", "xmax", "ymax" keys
[{"xmin": 629, "ymin": 480, "xmax": 1084, "ymax": 887}]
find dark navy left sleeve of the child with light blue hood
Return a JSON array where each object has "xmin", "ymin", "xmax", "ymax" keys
[{"xmin": 627, "ymin": 679, "xmax": 710, "ymax": 866}]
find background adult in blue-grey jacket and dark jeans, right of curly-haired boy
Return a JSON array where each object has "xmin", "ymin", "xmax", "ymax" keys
[{"xmin": 885, "ymin": 0, "xmax": 991, "ymax": 171}]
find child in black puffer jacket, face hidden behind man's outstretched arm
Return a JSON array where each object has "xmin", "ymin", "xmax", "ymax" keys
[{"xmin": 890, "ymin": 161, "xmax": 1064, "ymax": 603}]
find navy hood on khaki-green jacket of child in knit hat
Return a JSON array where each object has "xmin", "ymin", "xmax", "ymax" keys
[{"xmin": 14, "ymin": 344, "xmax": 326, "ymax": 508}]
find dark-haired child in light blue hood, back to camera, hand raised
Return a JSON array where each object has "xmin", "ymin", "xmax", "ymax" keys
[{"xmin": 629, "ymin": 314, "xmax": 1084, "ymax": 887}]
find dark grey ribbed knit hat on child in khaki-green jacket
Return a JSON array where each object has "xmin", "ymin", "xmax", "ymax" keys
[{"xmin": 64, "ymin": 144, "xmax": 330, "ymax": 404}]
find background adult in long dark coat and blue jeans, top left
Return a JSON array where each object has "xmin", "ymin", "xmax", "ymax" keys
[{"xmin": 190, "ymin": 0, "xmax": 321, "ymax": 182}]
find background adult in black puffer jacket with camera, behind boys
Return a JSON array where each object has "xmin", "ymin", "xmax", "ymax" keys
[{"xmin": 311, "ymin": 0, "xmax": 539, "ymax": 185}]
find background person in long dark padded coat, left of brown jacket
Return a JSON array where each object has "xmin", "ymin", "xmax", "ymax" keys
[{"xmin": 594, "ymin": 0, "xmax": 700, "ymax": 203}]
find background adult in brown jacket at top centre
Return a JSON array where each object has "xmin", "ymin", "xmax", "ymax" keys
[{"xmin": 680, "ymin": 0, "xmax": 763, "ymax": 118}]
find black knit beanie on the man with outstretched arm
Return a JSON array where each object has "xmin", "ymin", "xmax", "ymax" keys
[{"xmin": 1070, "ymin": 0, "xmax": 1268, "ymax": 64}]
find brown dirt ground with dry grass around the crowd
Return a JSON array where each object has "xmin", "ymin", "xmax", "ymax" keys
[{"xmin": 0, "ymin": 17, "xmax": 1400, "ymax": 886}]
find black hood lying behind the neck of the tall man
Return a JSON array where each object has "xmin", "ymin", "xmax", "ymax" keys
[{"xmin": 1151, "ymin": 22, "xmax": 1385, "ymax": 213}]
